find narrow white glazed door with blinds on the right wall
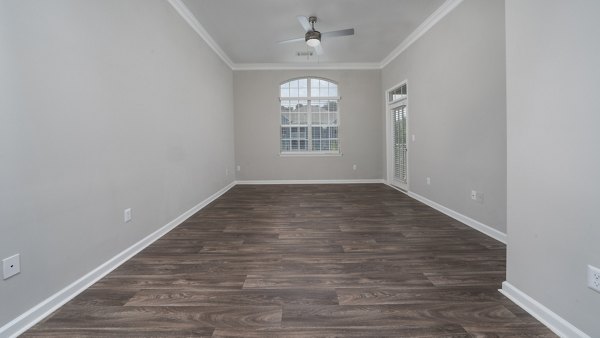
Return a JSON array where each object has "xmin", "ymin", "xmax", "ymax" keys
[{"xmin": 390, "ymin": 101, "xmax": 408, "ymax": 190}]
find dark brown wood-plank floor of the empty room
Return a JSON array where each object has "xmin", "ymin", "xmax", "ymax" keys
[{"xmin": 23, "ymin": 184, "xmax": 555, "ymax": 337}]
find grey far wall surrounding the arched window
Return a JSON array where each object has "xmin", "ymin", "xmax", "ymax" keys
[{"xmin": 233, "ymin": 70, "xmax": 383, "ymax": 180}]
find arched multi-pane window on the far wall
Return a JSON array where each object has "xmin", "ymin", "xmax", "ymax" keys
[{"xmin": 280, "ymin": 77, "xmax": 340, "ymax": 154}]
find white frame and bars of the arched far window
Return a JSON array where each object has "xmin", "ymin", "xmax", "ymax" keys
[{"xmin": 277, "ymin": 76, "xmax": 342, "ymax": 157}]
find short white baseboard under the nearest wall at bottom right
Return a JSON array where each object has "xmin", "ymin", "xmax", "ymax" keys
[{"xmin": 498, "ymin": 281, "xmax": 590, "ymax": 338}]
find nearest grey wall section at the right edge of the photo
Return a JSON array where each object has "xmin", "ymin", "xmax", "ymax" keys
[{"xmin": 506, "ymin": 0, "xmax": 600, "ymax": 337}]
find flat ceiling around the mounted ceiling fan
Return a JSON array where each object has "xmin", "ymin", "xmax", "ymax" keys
[{"xmin": 183, "ymin": 0, "xmax": 444, "ymax": 64}]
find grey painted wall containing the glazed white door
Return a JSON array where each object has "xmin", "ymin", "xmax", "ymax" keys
[{"xmin": 381, "ymin": 0, "xmax": 506, "ymax": 232}]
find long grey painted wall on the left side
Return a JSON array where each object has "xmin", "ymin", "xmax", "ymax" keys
[{"xmin": 0, "ymin": 0, "xmax": 234, "ymax": 327}]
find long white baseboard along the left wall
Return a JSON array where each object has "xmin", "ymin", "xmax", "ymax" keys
[{"xmin": 0, "ymin": 182, "xmax": 235, "ymax": 337}]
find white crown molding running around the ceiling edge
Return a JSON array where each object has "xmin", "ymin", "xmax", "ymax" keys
[{"xmin": 167, "ymin": 0, "xmax": 463, "ymax": 70}]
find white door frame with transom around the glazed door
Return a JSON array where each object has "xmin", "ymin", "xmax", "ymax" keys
[{"xmin": 384, "ymin": 80, "xmax": 411, "ymax": 191}]
